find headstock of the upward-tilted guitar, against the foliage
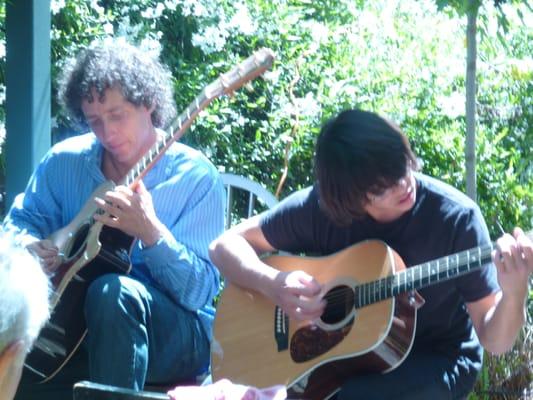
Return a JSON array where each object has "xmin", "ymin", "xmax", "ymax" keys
[{"xmin": 204, "ymin": 48, "xmax": 274, "ymax": 99}]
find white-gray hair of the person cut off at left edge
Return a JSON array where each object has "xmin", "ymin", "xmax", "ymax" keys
[{"xmin": 0, "ymin": 230, "xmax": 50, "ymax": 353}]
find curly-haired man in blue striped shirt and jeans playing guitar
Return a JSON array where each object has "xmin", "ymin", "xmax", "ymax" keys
[{"xmin": 5, "ymin": 39, "xmax": 225, "ymax": 399}]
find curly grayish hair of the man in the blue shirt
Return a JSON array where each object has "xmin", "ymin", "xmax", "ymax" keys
[{"xmin": 59, "ymin": 38, "xmax": 176, "ymax": 128}]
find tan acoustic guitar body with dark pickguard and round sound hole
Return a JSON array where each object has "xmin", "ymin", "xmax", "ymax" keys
[{"xmin": 211, "ymin": 241, "xmax": 423, "ymax": 399}]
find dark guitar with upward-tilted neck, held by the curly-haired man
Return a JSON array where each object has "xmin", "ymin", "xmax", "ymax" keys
[{"xmin": 25, "ymin": 49, "xmax": 274, "ymax": 382}]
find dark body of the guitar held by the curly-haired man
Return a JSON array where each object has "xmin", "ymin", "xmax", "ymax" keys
[{"xmin": 25, "ymin": 181, "xmax": 134, "ymax": 382}]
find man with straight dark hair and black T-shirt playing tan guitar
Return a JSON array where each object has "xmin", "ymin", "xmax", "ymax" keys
[{"xmin": 210, "ymin": 110, "xmax": 533, "ymax": 400}]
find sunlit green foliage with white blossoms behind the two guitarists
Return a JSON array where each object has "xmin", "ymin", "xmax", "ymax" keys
[{"xmin": 0, "ymin": 0, "xmax": 533, "ymax": 235}]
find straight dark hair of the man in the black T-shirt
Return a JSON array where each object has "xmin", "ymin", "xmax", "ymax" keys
[{"xmin": 315, "ymin": 110, "xmax": 418, "ymax": 225}]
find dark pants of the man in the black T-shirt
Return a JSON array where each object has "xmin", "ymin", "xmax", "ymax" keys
[{"xmin": 336, "ymin": 351, "xmax": 481, "ymax": 400}]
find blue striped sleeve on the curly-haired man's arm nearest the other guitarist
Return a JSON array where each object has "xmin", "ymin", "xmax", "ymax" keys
[{"xmin": 138, "ymin": 152, "xmax": 225, "ymax": 311}]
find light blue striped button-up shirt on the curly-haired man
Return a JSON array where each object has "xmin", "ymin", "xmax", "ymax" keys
[{"xmin": 4, "ymin": 133, "xmax": 225, "ymax": 338}]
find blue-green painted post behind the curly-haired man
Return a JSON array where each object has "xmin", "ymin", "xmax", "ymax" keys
[{"xmin": 4, "ymin": 0, "xmax": 51, "ymax": 211}]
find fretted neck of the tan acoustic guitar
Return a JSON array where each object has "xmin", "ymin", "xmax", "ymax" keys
[{"xmin": 354, "ymin": 231, "xmax": 533, "ymax": 308}]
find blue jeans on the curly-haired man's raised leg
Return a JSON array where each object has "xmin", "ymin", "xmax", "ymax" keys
[{"xmin": 85, "ymin": 274, "xmax": 209, "ymax": 390}]
